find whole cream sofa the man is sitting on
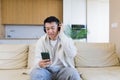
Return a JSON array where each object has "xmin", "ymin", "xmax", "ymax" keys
[{"xmin": 0, "ymin": 41, "xmax": 120, "ymax": 80}]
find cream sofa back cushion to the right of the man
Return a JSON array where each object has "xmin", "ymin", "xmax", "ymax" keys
[{"xmin": 75, "ymin": 41, "xmax": 120, "ymax": 67}]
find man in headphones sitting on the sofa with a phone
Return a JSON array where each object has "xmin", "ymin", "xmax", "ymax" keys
[{"xmin": 30, "ymin": 16, "xmax": 81, "ymax": 80}]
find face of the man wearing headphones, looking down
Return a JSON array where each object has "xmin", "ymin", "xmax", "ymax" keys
[{"xmin": 45, "ymin": 22, "xmax": 58, "ymax": 40}]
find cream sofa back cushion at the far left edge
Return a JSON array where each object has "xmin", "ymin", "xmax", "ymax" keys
[{"xmin": 0, "ymin": 44, "xmax": 28, "ymax": 69}]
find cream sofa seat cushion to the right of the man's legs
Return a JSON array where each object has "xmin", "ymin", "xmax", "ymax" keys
[{"xmin": 77, "ymin": 66, "xmax": 120, "ymax": 80}]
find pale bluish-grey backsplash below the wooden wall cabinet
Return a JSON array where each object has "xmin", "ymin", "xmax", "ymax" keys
[{"xmin": 5, "ymin": 25, "xmax": 45, "ymax": 38}]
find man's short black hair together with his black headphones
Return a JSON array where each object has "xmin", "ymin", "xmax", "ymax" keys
[{"xmin": 44, "ymin": 16, "xmax": 60, "ymax": 32}]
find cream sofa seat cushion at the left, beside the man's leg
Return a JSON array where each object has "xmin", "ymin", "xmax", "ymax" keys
[{"xmin": 0, "ymin": 69, "xmax": 30, "ymax": 80}]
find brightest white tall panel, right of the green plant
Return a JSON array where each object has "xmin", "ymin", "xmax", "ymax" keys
[{"xmin": 87, "ymin": 0, "xmax": 109, "ymax": 42}]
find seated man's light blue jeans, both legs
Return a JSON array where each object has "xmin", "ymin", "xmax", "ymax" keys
[{"xmin": 30, "ymin": 67, "xmax": 82, "ymax": 80}]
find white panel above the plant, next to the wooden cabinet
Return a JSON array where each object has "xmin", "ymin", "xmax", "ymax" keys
[{"xmin": 63, "ymin": 0, "xmax": 86, "ymax": 25}]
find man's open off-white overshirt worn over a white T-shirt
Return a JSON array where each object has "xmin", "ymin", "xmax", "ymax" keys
[{"xmin": 34, "ymin": 32, "xmax": 76, "ymax": 68}]
